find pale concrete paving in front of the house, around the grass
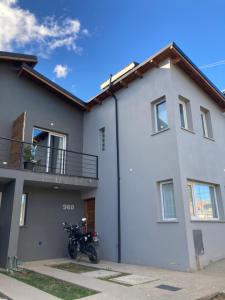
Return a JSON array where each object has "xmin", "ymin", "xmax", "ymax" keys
[{"xmin": 0, "ymin": 259, "xmax": 225, "ymax": 300}]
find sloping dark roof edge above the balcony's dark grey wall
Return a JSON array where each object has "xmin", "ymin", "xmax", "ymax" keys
[{"xmin": 19, "ymin": 64, "xmax": 88, "ymax": 110}]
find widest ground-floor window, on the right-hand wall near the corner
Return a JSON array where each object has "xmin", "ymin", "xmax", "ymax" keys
[{"xmin": 188, "ymin": 182, "xmax": 219, "ymax": 220}]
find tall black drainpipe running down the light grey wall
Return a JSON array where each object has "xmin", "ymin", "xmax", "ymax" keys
[{"xmin": 108, "ymin": 75, "xmax": 121, "ymax": 263}]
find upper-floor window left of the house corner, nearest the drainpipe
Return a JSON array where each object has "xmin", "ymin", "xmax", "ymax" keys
[{"xmin": 154, "ymin": 100, "xmax": 168, "ymax": 132}]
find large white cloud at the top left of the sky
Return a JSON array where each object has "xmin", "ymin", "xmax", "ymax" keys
[{"xmin": 0, "ymin": 0, "xmax": 88, "ymax": 56}]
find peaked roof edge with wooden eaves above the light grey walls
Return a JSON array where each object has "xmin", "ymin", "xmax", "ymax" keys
[{"xmin": 88, "ymin": 43, "xmax": 225, "ymax": 109}]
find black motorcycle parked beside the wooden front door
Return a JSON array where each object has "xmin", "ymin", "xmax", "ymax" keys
[{"xmin": 63, "ymin": 218, "xmax": 99, "ymax": 264}]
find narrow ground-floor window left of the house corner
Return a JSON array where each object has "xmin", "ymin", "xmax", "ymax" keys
[{"xmin": 160, "ymin": 180, "xmax": 176, "ymax": 220}]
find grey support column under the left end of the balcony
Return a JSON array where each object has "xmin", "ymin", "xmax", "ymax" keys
[{"xmin": 0, "ymin": 178, "xmax": 24, "ymax": 267}]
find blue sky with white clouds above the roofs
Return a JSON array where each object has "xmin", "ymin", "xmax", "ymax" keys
[{"xmin": 0, "ymin": 0, "xmax": 225, "ymax": 101}]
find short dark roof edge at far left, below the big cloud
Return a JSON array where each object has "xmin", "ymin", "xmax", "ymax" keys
[{"xmin": 0, "ymin": 51, "xmax": 38, "ymax": 67}]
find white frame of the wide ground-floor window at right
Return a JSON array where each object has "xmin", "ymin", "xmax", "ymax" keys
[{"xmin": 187, "ymin": 181, "xmax": 220, "ymax": 222}]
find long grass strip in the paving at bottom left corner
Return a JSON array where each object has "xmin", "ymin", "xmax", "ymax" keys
[{"xmin": 0, "ymin": 270, "xmax": 97, "ymax": 300}]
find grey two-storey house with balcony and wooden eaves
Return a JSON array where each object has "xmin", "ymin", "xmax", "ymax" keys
[{"xmin": 0, "ymin": 43, "xmax": 225, "ymax": 271}]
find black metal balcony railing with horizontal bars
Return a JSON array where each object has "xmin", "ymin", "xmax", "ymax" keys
[{"xmin": 0, "ymin": 137, "xmax": 98, "ymax": 179}]
